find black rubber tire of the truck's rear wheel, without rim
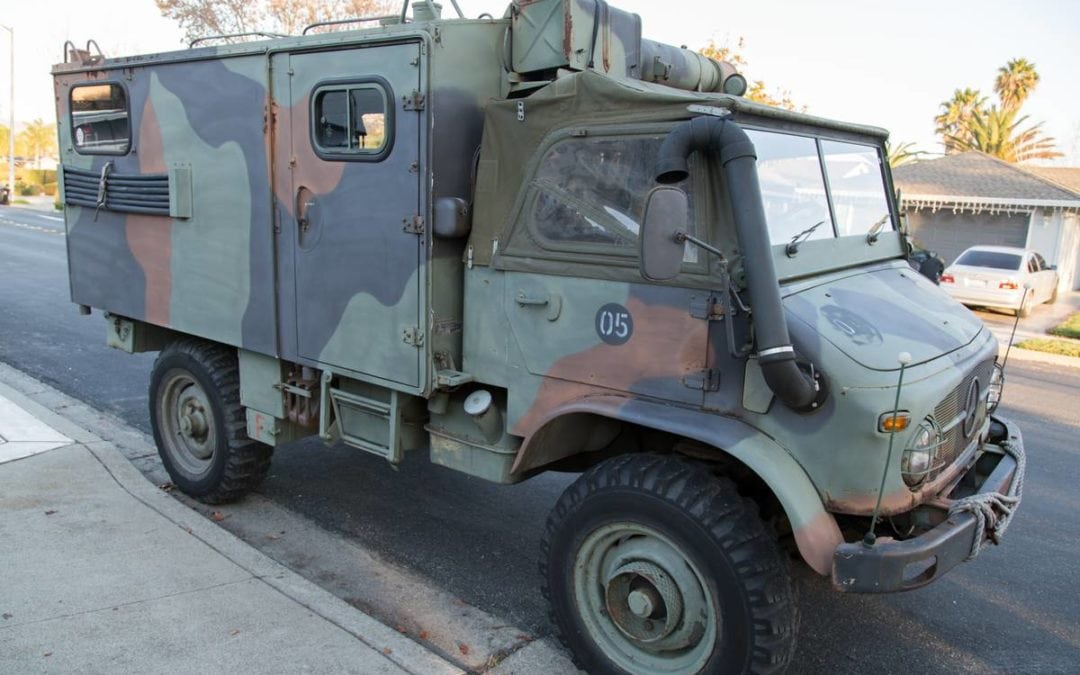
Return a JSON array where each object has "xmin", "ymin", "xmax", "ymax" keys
[{"xmin": 150, "ymin": 338, "xmax": 273, "ymax": 504}]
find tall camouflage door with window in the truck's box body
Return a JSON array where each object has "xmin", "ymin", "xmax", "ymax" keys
[{"xmin": 272, "ymin": 42, "xmax": 426, "ymax": 390}]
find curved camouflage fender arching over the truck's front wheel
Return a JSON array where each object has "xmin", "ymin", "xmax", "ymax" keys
[{"xmin": 513, "ymin": 395, "xmax": 843, "ymax": 575}]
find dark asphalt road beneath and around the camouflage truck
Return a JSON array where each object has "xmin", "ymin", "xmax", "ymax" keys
[{"xmin": 0, "ymin": 207, "xmax": 1080, "ymax": 673}]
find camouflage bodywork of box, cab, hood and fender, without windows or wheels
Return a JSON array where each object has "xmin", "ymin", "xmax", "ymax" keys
[{"xmin": 54, "ymin": 2, "xmax": 996, "ymax": 573}]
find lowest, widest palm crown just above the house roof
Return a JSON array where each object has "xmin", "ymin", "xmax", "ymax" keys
[{"xmin": 945, "ymin": 106, "xmax": 1062, "ymax": 163}]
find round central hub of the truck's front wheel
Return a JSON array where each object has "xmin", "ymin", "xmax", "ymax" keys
[{"xmin": 605, "ymin": 561, "xmax": 683, "ymax": 642}]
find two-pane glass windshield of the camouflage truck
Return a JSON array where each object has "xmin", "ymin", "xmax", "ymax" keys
[{"xmin": 746, "ymin": 129, "xmax": 892, "ymax": 245}]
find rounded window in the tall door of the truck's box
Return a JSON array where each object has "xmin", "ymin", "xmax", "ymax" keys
[{"xmin": 311, "ymin": 83, "xmax": 392, "ymax": 160}]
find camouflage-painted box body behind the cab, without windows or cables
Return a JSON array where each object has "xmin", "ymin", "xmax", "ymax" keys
[{"xmin": 54, "ymin": 21, "xmax": 505, "ymax": 393}]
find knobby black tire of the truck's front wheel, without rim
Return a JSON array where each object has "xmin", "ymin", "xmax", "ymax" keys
[{"xmin": 540, "ymin": 455, "xmax": 798, "ymax": 675}]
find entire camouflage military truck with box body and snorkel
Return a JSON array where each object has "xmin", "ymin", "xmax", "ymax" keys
[{"xmin": 53, "ymin": 0, "xmax": 1023, "ymax": 673}]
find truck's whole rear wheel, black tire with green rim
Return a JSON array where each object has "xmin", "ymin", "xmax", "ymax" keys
[{"xmin": 150, "ymin": 339, "xmax": 272, "ymax": 503}]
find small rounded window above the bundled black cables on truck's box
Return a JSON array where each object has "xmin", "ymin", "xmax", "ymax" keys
[{"xmin": 71, "ymin": 82, "xmax": 132, "ymax": 154}]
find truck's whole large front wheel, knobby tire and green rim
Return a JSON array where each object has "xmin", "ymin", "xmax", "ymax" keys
[{"xmin": 541, "ymin": 455, "xmax": 797, "ymax": 674}]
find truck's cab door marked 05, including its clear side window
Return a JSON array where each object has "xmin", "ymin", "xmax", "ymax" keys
[{"xmin": 495, "ymin": 126, "xmax": 713, "ymax": 408}]
